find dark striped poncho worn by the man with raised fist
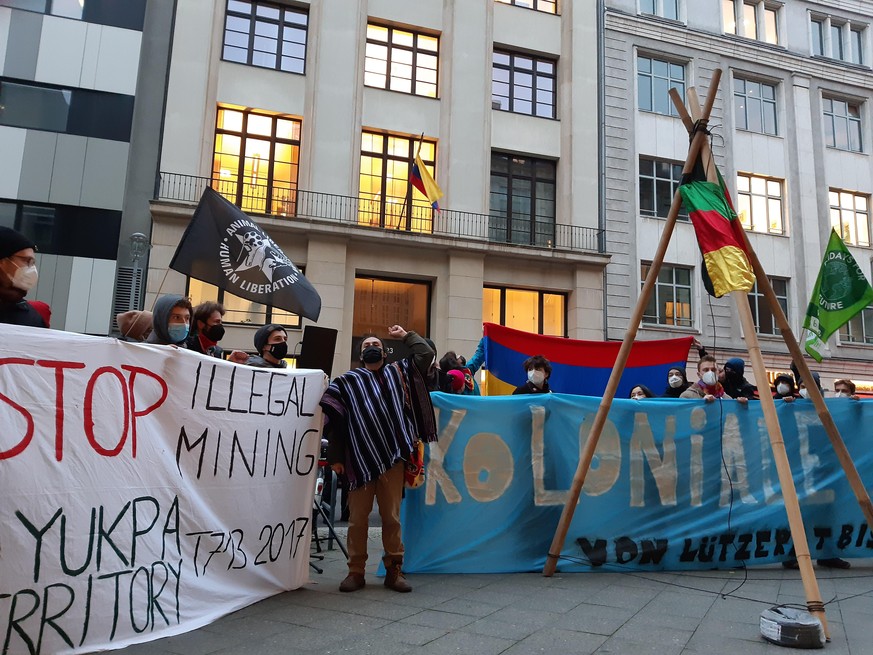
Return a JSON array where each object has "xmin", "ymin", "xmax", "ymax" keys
[{"xmin": 321, "ymin": 359, "xmax": 437, "ymax": 490}]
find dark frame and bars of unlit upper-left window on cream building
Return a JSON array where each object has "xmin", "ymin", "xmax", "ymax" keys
[{"xmin": 221, "ymin": 0, "xmax": 309, "ymax": 75}]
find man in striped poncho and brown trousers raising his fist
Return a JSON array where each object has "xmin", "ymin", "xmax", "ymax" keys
[{"xmin": 321, "ymin": 325, "xmax": 437, "ymax": 592}]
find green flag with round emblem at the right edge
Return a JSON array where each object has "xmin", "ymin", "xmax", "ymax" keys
[{"xmin": 803, "ymin": 229, "xmax": 873, "ymax": 362}]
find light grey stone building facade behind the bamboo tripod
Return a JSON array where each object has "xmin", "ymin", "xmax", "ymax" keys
[{"xmin": 603, "ymin": 0, "xmax": 873, "ymax": 389}]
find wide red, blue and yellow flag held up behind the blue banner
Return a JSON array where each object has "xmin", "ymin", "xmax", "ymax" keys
[{"xmin": 485, "ymin": 323, "xmax": 693, "ymax": 398}]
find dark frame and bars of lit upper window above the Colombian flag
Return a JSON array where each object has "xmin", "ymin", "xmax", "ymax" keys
[{"xmin": 364, "ymin": 21, "xmax": 441, "ymax": 100}]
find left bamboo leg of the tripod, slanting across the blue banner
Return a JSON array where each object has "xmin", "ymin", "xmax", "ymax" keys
[{"xmin": 543, "ymin": 69, "xmax": 721, "ymax": 576}]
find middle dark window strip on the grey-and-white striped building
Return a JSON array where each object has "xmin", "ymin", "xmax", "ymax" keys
[{"xmin": 0, "ymin": 78, "xmax": 134, "ymax": 141}]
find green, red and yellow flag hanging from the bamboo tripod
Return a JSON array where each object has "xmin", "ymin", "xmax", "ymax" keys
[{"xmin": 679, "ymin": 168, "xmax": 755, "ymax": 298}]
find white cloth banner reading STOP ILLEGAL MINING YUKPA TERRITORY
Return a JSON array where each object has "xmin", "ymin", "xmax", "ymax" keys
[{"xmin": 0, "ymin": 325, "xmax": 327, "ymax": 654}]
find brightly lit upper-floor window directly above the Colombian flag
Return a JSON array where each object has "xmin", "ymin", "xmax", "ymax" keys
[{"xmin": 364, "ymin": 24, "xmax": 440, "ymax": 98}]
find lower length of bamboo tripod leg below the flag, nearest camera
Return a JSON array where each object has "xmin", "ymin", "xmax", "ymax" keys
[{"xmin": 731, "ymin": 291, "xmax": 830, "ymax": 639}]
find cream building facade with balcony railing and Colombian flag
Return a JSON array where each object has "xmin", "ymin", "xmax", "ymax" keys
[{"xmin": 145, "ymin": 0, "xmax": 608, "ymax": 377}]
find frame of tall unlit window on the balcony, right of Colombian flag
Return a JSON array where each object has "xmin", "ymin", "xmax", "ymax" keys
[{"xmin": 488, "ymin": 150, "xmax": 558, "ymax": 247}]
